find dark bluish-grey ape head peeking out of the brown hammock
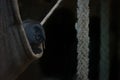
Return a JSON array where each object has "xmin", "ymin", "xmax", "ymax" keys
[{"xmin": 23, "ymin": 20, "xmax": 45, "ymax": 53}]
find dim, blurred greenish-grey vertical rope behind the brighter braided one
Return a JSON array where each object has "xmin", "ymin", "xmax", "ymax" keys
[{"xmin": 99, "ymin": 0, "xmax": 109, "ymax": 80}]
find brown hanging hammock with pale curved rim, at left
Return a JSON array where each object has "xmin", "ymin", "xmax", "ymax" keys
[{"xmin": 0, "ymin": 0, "xmax": 42, "ymax": 80}]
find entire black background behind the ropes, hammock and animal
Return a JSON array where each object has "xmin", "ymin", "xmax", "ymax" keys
[{"xmin": 18, "ymin": 0, "xmax": 120, "ymax": 80}]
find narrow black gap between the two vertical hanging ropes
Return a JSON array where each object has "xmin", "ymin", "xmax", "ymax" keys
[{"xmin": 89, "ymin": 0, "xmax": 100, "ymax": 80}]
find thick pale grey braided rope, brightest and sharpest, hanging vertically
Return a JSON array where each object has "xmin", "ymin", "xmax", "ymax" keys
[{"xmin": 76, "ymin": 0, "xmax": 89, "ymax": 80}]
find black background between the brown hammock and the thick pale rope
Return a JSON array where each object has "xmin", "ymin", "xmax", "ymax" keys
[{"xmin": 18, "ymin": 0, "xmax": 77, "ymax": 80}]
